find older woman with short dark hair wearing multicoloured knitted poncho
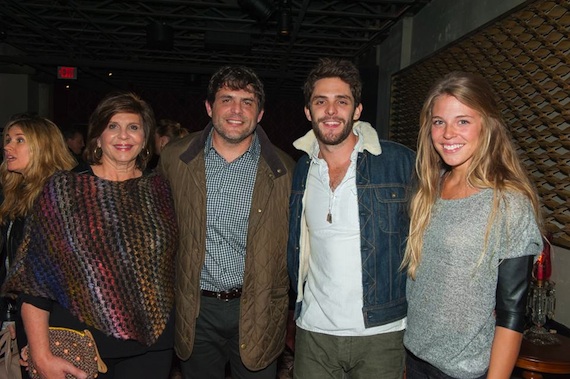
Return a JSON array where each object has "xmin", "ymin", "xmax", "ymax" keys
[{"xmin": 6, "ymin": 93, "xmax": 178, "ymax": 379}]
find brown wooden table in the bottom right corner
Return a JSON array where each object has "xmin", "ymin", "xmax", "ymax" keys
[{"xmin": 516, "ymin": 334, "xmax": 570, "ymax": 379}]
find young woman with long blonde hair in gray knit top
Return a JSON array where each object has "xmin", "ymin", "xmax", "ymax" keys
[{"xmin": 403, "ymin": 72, "xmax": 542, "ymax": 379}]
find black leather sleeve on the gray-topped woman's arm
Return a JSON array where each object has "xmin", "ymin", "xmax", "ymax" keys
[{"xmin": 495, "ymin": 255, "xmax": 534, "ymax": 333}]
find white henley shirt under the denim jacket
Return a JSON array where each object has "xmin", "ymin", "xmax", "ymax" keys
[{"xmin": 297, "ymin": 130, "xmax": 405, "ymax": 336}]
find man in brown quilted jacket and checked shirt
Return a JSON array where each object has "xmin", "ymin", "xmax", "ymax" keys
[{"xmin": 158, "ymin": 66, "xmax": 293, "ymax": 379}]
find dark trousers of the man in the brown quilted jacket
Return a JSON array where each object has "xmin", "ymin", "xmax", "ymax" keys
[{"xmin": 180, "ymin": 296, "xmax": 277, "ymax": 379}]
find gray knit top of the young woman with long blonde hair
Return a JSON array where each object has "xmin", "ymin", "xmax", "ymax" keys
[{"xmin": 404, "ymin": 189, "xmax": 542, "ymax": 379}]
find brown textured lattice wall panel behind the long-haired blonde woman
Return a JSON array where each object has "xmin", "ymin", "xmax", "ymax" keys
[{"xmin": 390, "ymin": 0, "xmax": 570, "ymax": 247}]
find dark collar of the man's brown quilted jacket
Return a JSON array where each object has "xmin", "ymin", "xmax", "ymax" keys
[{"xmin": 180, "ymin": 121, "xmax": 287, "ymax": 178}]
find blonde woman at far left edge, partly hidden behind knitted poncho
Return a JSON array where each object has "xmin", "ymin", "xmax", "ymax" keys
[{"xmin": 0, "ymin": 115, "xmax": 76, "ymax": 376}]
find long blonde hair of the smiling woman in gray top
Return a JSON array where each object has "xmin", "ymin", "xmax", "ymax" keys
[{"xmin": 402, "ymin": 72, "xmax": 542, "ymax": 279}]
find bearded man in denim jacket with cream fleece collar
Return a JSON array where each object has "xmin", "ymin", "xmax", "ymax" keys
[{"xmin": 288, "ymin": 58, "xmax": 415, "ymax": 379}]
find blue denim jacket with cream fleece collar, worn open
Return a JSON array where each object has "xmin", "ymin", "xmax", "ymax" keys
[{"xmin": 287, "ymin": 121, "xmax": 415, "ymax": 328}]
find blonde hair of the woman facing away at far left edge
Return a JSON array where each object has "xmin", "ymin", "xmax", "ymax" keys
[{"xmin": 0, "ymin": 115, "xmax": 77, "ymax": 224}]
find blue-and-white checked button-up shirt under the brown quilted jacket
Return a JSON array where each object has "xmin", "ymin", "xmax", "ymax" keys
[{"xmin": 200, "ymin": 129, "xmax": 261, "ymax": 292}]
